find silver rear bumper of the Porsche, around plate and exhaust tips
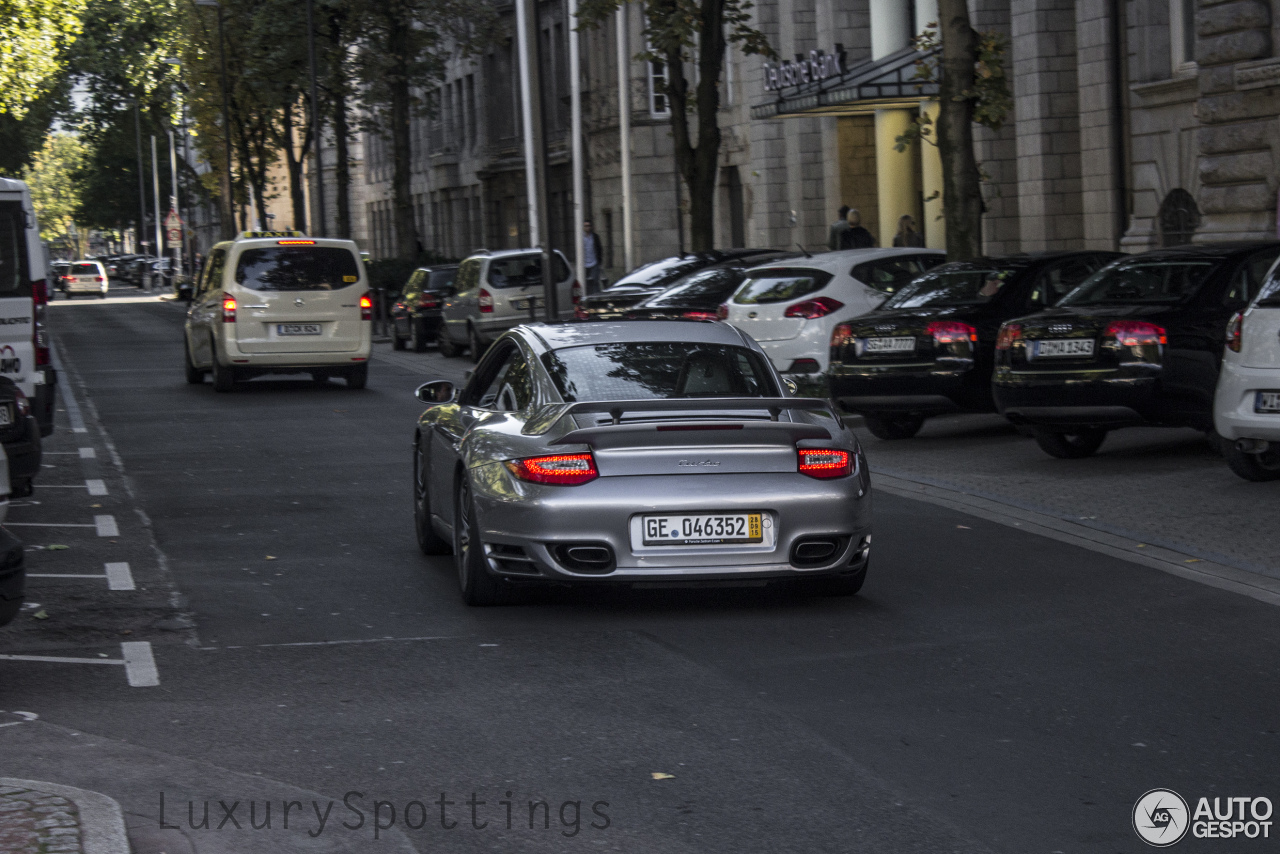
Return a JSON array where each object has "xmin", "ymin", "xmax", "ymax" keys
[{"xmin": 472, "ymin": 460, "xmax": 872, "ymax": 583}]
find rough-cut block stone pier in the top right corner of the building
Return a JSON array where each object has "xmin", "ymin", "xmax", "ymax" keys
[{"xmin": 1194, "ymin": 0, "xmax": 1280, "ymax": 243}]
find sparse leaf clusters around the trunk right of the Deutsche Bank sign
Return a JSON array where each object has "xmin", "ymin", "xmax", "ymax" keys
[{"xmin": 893, "ymin": 24, "xmax": 1014, "ymax": 151}]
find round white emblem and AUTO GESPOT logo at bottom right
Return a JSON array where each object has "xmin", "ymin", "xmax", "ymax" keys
[{"xmin": 1133, "ymin": 789, "xmax": 1272, "ymax": 848}]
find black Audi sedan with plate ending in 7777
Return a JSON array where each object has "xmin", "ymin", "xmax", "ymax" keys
[{"xmin": 828, "ymin": 252, "xmax": 1120, "ymax": 439}]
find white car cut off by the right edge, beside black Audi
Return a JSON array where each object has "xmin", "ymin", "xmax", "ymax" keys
[{"xmin": 1213, "ymin": 253, "xmax": 1280, "ymax": 480}]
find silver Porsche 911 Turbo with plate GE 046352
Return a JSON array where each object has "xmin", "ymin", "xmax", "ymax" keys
[{"xmin": 413, "ymin": 320, "xmax": 870, "ymax": 606}]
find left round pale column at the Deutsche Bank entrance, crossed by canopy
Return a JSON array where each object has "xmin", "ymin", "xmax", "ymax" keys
[{"xmin": 864, "ymin": 0, "xmax": 920, "ymax": 246}]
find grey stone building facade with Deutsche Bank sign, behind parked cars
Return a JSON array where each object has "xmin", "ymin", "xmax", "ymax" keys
[{"xmin": 357, "ymin": 0, "xmax": 1280, "ymax": 277}]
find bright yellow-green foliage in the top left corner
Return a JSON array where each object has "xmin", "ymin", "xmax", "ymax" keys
[{"xmin": 0, "ymin": 0, "xmax": 84, "ymax": 119}]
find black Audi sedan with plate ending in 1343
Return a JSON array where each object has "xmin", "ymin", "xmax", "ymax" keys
[{"xmin": 992, "ymin": 242, "xmax": 1280, "ymax": 458}]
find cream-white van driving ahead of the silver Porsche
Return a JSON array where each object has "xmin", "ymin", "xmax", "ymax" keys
[{"xmin": 186, "ymin": 232, "xmax": 374, "ymax": 392}]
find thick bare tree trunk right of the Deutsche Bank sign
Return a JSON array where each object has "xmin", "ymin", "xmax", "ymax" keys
[{"xmin": 938, "ymin": 0, "xmax": 983, "ymax": 261}]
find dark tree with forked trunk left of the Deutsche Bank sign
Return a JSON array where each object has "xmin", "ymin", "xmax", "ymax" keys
[{"xmin": 579, "ymin": 0, "xmax": 776, "ymax": 252}]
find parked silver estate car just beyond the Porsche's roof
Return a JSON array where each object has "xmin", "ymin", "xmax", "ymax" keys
[{"xmin": 436, "ymin": 250, "xmax": 576, "ymax": 361}]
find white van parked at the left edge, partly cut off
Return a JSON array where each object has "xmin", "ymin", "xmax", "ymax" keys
[{"xmin": 0, "ymin": 178, "xmax": 58, "ymax": 435}]
